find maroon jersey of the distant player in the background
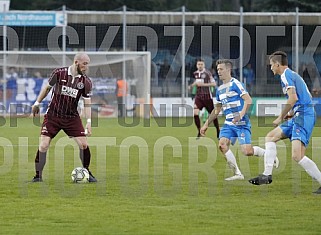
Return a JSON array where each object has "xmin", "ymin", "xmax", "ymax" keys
[{"xmin": 193, "ymin": 69, "xmax": 214, "ymax": 100}]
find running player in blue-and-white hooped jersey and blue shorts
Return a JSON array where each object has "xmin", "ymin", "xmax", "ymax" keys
[{"xmin": 201, "ymin": 59, "xmax": 278, "ymax": 181}]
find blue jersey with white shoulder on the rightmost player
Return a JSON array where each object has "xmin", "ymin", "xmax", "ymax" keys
[{"xmin": 281, "ymin": 68, "xmax": 312, "ymax": 112}]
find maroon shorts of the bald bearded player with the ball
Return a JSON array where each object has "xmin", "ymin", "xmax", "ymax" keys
[{"xmin": 41, "ymin": 114, "xmax": 86, "ymax": 138}]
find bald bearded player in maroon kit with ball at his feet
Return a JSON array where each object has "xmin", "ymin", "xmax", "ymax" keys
[{"xmin": 32, "ymin": 53, "xmax": 97, "ymax": 182}]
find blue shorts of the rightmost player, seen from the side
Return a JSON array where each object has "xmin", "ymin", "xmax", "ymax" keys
[{"xmin": 280, "ymin": 110, "xmax": 315, "ymax": 147}]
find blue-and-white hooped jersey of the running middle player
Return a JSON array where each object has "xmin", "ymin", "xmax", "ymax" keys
[{"xmin": 216, "ymin": 78, "xmax": 250, "ymax": 125}]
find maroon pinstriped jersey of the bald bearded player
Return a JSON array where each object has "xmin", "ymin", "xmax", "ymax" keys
[{"xmin": 46, "ymin": 67, "xmax": 92, "ymax": 118}]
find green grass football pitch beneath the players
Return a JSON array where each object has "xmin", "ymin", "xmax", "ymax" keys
[{"xmin": 0, "ymin": 117, "xmax": 321, "ymax": 235}]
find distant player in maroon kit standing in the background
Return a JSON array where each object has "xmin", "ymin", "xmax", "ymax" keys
[{"xmin": 189, "ymin": 59, "xmax": 220, "ymax": 138}]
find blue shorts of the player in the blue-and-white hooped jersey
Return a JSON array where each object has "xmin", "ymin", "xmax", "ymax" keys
[{"xmin": 219, "ymin": 124, "xmax": 251, "ymax": 145}]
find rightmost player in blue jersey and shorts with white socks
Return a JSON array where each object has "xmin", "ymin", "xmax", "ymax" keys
[{"xmin": 249, "ymin": 51, "xmax": 321, "ymax": 194}]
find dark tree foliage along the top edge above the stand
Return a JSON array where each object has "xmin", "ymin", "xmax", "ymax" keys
[{"xmin": 10, "ymin": 0, "xmax": 321, "ymax": 12}]
